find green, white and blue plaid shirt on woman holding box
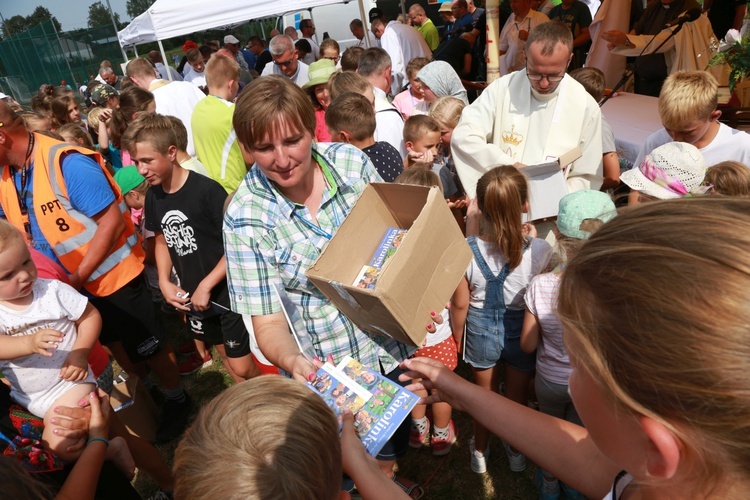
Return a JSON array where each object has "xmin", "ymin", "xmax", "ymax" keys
[{"xmin": 224, "ymin": 143, "xmax": 408, "ymax": 373}]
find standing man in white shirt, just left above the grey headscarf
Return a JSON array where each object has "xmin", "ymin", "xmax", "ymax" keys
[{"xmin": 370, "ymin": 8, "xmax": 432, "ymax": 96}]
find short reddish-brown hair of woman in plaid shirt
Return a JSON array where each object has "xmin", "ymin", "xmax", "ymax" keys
[{"xmin": 232, "ymin": 74, "xmax": 315, "ymax": 149}]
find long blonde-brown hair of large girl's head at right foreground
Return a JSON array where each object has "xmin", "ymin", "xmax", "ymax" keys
[{"xmin": 558, "ymin": 196, "xmax": 750, "ymax": 490}]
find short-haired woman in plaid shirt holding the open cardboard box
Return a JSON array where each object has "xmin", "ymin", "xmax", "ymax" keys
[{"xmin": 224, "ymin": 76, "xmax": 434, "ymax": 496}]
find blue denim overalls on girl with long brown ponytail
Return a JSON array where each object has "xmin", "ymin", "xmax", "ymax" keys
[{"xmin": 464, "ymin": 236, "xmax": 529, "ymax": 369}]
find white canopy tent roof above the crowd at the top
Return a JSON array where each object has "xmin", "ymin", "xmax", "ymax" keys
[{"xmin": 118, "ymin": 0, "xmax": 374, "ymax": 48}]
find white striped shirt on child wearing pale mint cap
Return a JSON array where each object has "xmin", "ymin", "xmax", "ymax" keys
[{"xmin": 526, "ymin": 273, "xmax": 573, "ymax": 385}]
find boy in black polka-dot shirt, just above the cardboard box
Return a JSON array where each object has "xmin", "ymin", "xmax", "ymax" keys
[{"xmin": 326, "ymin": 92, "xmax": 404, "ymax": 182}]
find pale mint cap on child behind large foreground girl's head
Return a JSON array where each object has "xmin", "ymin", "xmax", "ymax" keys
[{"xmin": 557, "ymin": 189, "xmax": 617, "ymax": 240}]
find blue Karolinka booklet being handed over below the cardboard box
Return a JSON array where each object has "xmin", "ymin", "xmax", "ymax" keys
[{"xmin": 307, "ymin": 356, "xmax": 419, "ymax": 456}]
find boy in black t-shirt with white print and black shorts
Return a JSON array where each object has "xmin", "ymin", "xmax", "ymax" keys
[{"xmin": 123, "ymin": 113, "xmax": 259, "ymax": 381}]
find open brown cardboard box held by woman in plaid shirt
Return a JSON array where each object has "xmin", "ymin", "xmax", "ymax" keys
[{"xmin": 307, "ymin": 183, "xmax": 472, "ymax": 346}]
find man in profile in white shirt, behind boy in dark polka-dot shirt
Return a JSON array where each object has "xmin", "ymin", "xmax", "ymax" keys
[{"xmin": 357, "ymin": 47, "xmax": 406, "ymax": 158}]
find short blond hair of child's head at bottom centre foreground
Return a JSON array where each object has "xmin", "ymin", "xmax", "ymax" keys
[{"xmin": 174, "ymin": 375, "xmax": 341, "ymax": 500}]
